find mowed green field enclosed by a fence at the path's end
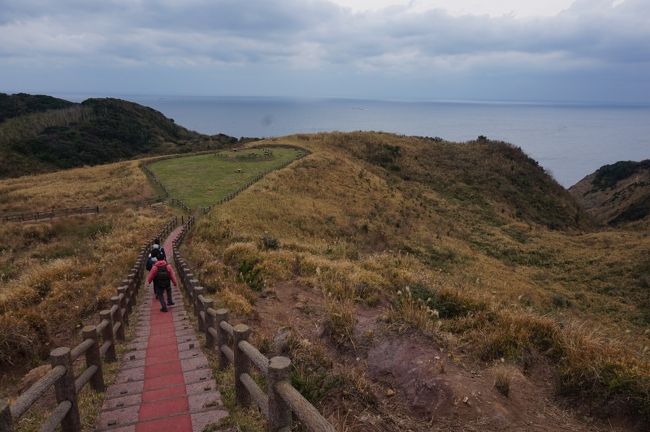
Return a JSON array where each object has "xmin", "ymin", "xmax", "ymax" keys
[{"xmin": 149, "ymin": 147, "xmax": 302, "ymax": 208}]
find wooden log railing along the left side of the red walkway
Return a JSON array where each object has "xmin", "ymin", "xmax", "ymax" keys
[{"xmin": 0, "ymin": 218, "xmax": 178, "ymax": 432}]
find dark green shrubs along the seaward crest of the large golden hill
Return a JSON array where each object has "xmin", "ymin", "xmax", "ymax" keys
[{"xmin": 345, "ymin": 135, "xmax": 590, "ymax": 229}]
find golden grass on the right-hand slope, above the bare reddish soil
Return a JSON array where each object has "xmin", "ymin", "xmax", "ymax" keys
[{"xmin": 182, "ymin": 133, "xmax": 650, "ymax": 430}]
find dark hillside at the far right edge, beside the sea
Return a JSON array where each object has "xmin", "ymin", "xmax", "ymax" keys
[{"xmin": 569, "ymin": 159, "xmax": 650, "ymax": 227}]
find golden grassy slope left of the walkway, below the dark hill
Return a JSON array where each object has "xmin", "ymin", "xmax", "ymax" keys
[{"xmin": 0, "ymin": 161, "xmax": 175, "ymax": 372}]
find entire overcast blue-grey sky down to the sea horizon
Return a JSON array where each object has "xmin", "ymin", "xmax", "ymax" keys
[{"xmin": 0, "ymin": 0, "xmax": 650, "ymax": 103}]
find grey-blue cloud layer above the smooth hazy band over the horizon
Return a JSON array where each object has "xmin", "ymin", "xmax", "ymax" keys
[{"xmin": 0, "ymin": 0, "xmax": 650, "ymax": 99}]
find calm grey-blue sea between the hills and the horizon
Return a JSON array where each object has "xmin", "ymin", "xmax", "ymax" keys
[{"xmin": 62, "ymin": 96, "xmax": 650, "ymax": 187}]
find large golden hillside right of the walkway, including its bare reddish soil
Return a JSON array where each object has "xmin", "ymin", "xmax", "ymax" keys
[{"xmin": 184, "ymin": 132, "xmax": 650, "ymax": 431}]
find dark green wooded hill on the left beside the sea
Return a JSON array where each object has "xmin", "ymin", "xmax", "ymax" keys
[{"xmin": 0, "ymin": 94, "xmax": 237, "ymax": 178}]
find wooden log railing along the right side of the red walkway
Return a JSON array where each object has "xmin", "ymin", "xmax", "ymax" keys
[{"xmin": 173, "ymin": 217, "xmax": 335, "ymax": 432}]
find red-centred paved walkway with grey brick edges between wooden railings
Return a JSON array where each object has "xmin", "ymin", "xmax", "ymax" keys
[{"xmin": 97, "ymin": 229, "xmax": 228, "ymax": 432}]
